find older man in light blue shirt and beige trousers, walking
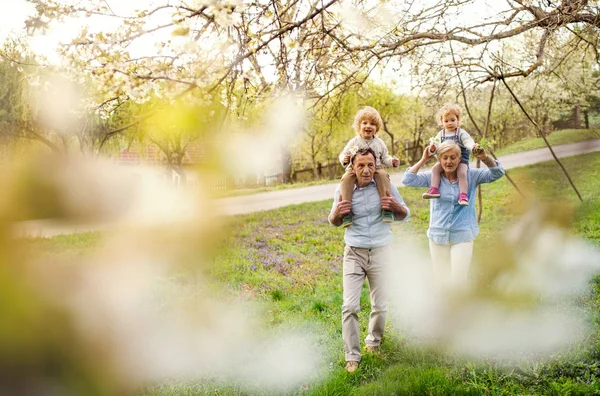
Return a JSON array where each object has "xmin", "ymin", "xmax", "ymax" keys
[{"xmin": 329, "ymin": 148, "xmax": 410, "ymax": 373}]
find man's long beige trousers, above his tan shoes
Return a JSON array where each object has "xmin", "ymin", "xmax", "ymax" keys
[{"xmin": 342, "ymin": 245, "xmax": 391, "ymax": 362}]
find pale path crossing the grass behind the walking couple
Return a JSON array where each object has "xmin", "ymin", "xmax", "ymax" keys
[{"xmin": 15, "ymin": 139, "xmax": 600, "ymax": 237}]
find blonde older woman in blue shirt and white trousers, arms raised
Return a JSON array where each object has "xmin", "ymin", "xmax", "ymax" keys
[{"xmin": 402, "ymin": 141, "xmax": 504, "ymax": 285}]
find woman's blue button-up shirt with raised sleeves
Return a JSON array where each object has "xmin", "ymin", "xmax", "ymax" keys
[{"xmin": 402, "ymin": 163, "xmax": 504, "ymax": 245}]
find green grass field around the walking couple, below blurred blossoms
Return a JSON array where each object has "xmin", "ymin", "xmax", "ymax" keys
[{"xmin": 27, "ymin": 153, "xmax": 600, "ymax": 395}]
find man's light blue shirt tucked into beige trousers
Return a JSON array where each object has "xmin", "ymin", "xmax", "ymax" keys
[{"xmin": 331, "ymin": 180, "xmax": 410, "ymax": 248}]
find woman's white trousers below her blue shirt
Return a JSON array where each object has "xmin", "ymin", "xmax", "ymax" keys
[{"xmin": 429, "ymin": 239, "xmax": 473, "ymax": 287}]
